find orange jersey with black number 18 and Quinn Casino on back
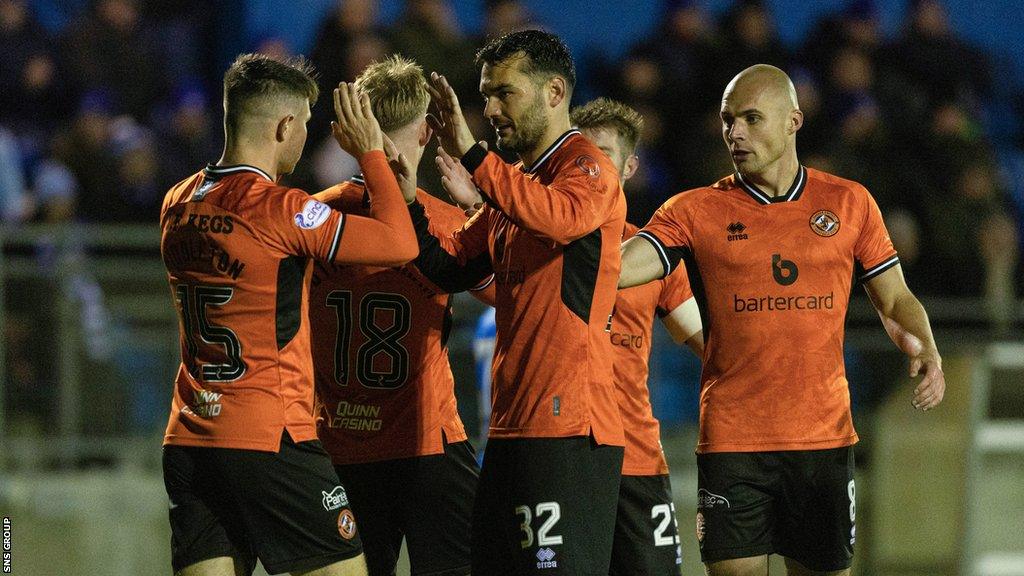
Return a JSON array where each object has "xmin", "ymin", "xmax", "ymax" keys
[{"xmin": 309, "ymin": 176, "xmax": 466, "ymax": 464}]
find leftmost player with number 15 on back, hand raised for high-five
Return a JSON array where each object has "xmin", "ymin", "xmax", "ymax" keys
[{"xmin": 161, "ymin": 54, "xmax": 417, "ymax": 576}]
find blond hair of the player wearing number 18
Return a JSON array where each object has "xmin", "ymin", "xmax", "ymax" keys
[{"xmin": 355, "ymin": 54, "xmax": 430, "ymax": 132}]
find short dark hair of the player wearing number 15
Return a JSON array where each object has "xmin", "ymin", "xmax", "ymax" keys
[{"xmin": 224, "ymin": 53, "xmax": 319, "ymax": 128}]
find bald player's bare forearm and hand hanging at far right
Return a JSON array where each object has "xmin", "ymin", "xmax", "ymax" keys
[{"xmin": 864, "ymin": 264, "xmax": 946, "ymax": 410}]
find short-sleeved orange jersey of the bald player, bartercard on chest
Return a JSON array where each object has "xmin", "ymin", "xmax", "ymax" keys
[{"xmin": 638, "ymin": 167, "xmax": 899, "ymax": 453}]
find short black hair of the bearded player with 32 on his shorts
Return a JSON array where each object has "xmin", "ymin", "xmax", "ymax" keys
[{"xmin": 476, "ymin": 30, "xmax": 575, "ymax": 93}]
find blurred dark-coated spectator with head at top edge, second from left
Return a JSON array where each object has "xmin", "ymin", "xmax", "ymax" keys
[{"xmin": 62, "ymin": 0, "xmax": 166, "ymax": 122}]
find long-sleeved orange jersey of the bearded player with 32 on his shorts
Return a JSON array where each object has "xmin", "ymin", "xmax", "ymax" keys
[{"xmin": 412, "ymin": 130, "xmax": 626, "ymax": 446}]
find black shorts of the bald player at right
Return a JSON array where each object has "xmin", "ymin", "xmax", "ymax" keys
[{"xmin": 697, "ymin": 446, "xmax": 856, "ymax": 571}]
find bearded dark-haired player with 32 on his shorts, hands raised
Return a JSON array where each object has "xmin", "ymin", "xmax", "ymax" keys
[{"xmin": 419, "ymin": 30, "xmax": 626, "ymax": 576}]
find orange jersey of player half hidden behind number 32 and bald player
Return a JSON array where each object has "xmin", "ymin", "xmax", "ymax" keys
[{"xmin": 610, "ymin": 223, "xmax": 693, "ymax": 476}]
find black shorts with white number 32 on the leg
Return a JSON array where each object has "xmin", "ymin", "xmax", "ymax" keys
[{"xmin": 471, "ymin": 437, "xmax": 623, "ymax": 576}]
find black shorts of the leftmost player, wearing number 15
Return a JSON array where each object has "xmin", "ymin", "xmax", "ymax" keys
[{"xmin": 164, "ymin": 431, "xmax": 362, "ymax": 574}]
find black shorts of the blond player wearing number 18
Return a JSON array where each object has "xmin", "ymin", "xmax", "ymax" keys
[{"xmin": 335, "ymin": 442, "xmax": 479, "ymax": 576}]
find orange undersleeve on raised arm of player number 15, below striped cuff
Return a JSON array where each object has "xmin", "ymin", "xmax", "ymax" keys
[{"xmin": 335, "ymin": 150, "xmax": 419, "ymax": 266}]
